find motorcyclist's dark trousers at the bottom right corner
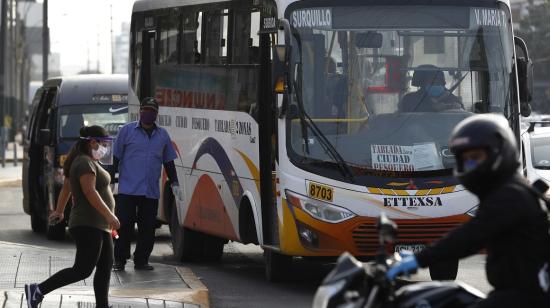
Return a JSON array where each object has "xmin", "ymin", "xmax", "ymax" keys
[{"xmin": 469, "ymin": 289, "xmax": 550, "ymax": 308}]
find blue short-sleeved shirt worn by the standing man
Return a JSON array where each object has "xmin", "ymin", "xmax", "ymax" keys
[{"xmin": 113, "ymin": 122, "xmax": 178, "ymax": 199}]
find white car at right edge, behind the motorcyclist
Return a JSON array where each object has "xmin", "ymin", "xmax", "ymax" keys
[{"xmin": 521, "ymin": 119, "xmax": 550, "ymax": 185}]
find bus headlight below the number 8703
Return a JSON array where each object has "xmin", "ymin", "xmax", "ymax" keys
[{"xmin": 286, "ymin": 190, "xmax": 357, "ymax": 223}]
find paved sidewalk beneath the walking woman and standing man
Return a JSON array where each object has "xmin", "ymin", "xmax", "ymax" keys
[{"xmin": 0, "ymin": 242, "xmax": 209, "ymax": 308}]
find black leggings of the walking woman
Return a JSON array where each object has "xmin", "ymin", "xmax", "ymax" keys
[{"xmin": 38, "ymin": 227, "xmax": 113, "ymax": 308}]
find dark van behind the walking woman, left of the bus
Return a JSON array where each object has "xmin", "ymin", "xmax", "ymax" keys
[{"xmin": 23, "ymin": 75, "xmax": 128, "ymax": 240}]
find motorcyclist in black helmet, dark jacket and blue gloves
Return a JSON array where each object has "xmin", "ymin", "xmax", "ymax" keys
[{"xmin": 387, "ymin": 114, "xmax": 550, "ymax": 307}]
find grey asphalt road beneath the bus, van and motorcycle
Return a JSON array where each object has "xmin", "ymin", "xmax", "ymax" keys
[{"xmin": 0, "ymin": 184, "xmax": 490, "ymax": 308}]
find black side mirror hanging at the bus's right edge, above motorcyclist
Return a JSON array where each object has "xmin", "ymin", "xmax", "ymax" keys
[{"xmin": 514, "ymin": 36, "xmax": 533, "ymax": 104}]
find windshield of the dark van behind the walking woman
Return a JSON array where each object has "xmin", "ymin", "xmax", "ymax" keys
[{"xmin": 58, "ymin": 104, "xmax": 128, "ymax": 138}]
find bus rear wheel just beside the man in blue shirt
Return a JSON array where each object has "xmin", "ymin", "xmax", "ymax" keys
[{"xmin": 170, "ymin": 205, "xmax": 202, "ymax": 262}]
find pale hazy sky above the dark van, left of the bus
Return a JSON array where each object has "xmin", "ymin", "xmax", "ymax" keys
[{"xmin": 48, "ymin": 0, "xmax": 134, "ymax": 75}]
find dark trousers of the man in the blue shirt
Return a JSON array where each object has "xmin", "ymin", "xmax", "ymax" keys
[{"xmin": 115, "ymin": 194, "xmax": 158, "ymax": 265}]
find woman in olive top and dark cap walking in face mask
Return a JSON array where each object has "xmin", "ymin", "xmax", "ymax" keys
[{"xmin": 25, "ymin": 126, "xmax": 120, "ymax": 308}]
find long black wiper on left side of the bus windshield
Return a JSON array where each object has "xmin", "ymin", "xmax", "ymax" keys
[{"xmin": 292, "ymin": 78, "xmax": 355, "ymax": 183}]
